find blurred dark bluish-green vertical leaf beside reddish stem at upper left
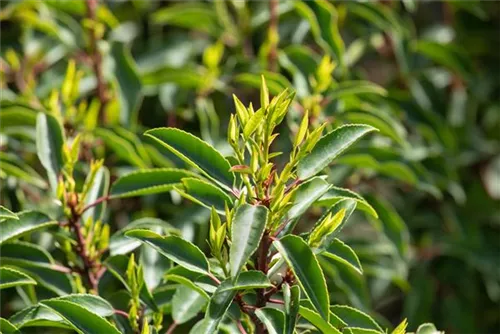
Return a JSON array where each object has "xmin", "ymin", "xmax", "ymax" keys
[{"xmin": 111, "ymin": 42, "xmax": 142, "ymax": 126}]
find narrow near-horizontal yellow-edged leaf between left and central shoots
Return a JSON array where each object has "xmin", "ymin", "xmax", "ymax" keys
[{"xmin": 110, "ymin": 168, "xmax": 194, "ymax": 198}]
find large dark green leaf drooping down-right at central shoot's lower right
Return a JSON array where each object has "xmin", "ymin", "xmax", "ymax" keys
[{"xmin": 273, "ymin": 235, "xmax": 330, "ymax": 321}]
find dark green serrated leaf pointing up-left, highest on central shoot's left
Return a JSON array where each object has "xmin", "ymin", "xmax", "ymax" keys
[{"xmin": 145, "ymin": 128, "xmax": 234, "ymax": 189}]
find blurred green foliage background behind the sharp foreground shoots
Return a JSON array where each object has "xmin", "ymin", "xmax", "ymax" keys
[{"xmin": 0, "ymin": 0, "xmax": 500, "ymax": 334}]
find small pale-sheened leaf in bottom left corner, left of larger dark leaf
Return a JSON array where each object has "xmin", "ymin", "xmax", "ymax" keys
[{"xmin": 9, "ymin": 305, "xmax": 71, "ymax": 328}]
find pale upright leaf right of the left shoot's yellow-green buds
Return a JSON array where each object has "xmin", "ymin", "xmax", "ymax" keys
[{"xmin": 82, "ymin": 166, "xmax": 110, "ymax": 222}]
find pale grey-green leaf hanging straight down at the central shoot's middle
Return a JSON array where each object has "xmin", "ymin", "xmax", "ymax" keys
[{"xmin": 229, "ymin": 204, "xmax": 269, "ymax": 279}]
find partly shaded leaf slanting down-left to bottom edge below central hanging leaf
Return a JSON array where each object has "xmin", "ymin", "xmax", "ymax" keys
[{"xmin": 196, "ymin": 279, "xmax": 237, "ymax": 334}]
